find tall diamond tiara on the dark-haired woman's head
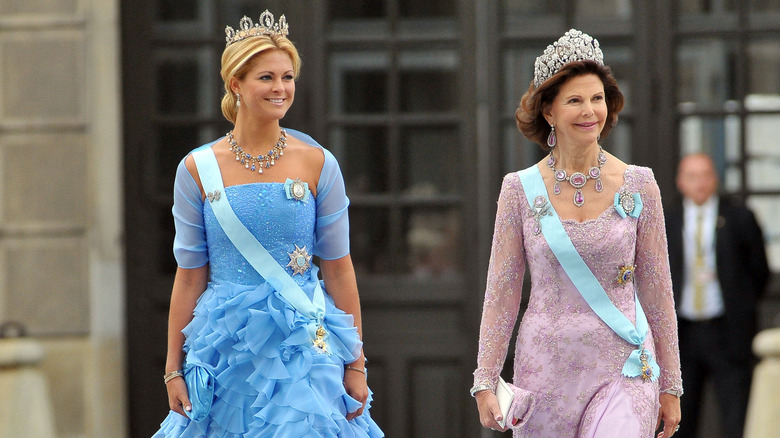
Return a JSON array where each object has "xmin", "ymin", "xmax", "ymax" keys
[{"xmin": 534, "ymin": 29, "xmax": 604, "ymax": 88}]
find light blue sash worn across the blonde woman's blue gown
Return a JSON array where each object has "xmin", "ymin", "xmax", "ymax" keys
[{"xmin": 192, "ymin": 148, "xmax": 325, "ymax": 326}]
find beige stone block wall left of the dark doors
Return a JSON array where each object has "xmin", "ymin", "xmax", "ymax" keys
[{"xmin": 0, "ymin": 0, "xmax": 126, "ymax": 437}]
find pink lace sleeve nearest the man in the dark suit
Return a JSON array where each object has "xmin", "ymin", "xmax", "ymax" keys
[{"xmin": 636, "ymin": 171, "xmax": 682, "ymax": 391}]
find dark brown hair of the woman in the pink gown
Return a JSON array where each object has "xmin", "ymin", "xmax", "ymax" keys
[{"xmin": 515, "ymin": 60, "xmax": 624, "ymax": 151}]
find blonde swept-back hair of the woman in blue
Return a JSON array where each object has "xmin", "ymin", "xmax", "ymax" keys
[{"xmin": 220, "ymin": 35, "xmax": 301, "ymax": 124}]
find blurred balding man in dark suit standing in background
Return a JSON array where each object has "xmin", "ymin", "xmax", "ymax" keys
[{"xmin": 666, "ymin": 154, "xmax": 769, "ymax": 438}]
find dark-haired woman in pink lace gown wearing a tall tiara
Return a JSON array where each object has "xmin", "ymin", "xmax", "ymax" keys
[{"xmin": 471, "ymin": 29, "xmax": 682, "ymax": 438}]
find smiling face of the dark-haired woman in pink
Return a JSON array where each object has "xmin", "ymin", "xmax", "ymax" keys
[{"xmin": 544, "ymin": 74, "xmax": 607, "ymax": 150}]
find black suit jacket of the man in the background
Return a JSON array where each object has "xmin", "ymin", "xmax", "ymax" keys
[{"xmin": 666, "ymin": 196, "xmax": 769, "ymax": 361}]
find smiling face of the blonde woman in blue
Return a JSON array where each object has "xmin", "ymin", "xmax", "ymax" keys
[{"xmin": 230, "ymin": 50, "xmax": 295, "ymax": 120}]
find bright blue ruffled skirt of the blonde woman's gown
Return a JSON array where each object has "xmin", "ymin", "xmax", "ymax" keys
[{"xmin": 153, "ymin": 282, "xmax": 384, "ymax": 438}]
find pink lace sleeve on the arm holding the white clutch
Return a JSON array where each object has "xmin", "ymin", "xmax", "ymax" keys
[{"xmin": 472, "ymin": 174, "xmax": 525, "ymax": 394}]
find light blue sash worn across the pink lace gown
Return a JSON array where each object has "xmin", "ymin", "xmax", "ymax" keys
[{"xmin": 518, "ymin": 166, "xmax": 660, "ymax": 381}]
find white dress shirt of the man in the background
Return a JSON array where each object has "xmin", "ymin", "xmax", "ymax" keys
[{"xmin": 679, "ymin": 196, "xmax": 724, "ymax": 321}]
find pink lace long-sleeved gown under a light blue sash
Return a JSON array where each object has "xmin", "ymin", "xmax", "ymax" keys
[{"xmin": 474, "ymin": 166, "xmax": 682, "ymax": 438}]
